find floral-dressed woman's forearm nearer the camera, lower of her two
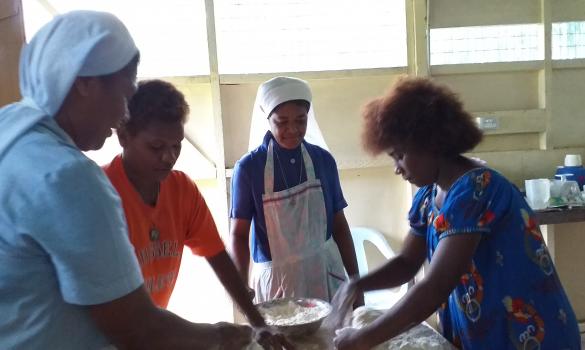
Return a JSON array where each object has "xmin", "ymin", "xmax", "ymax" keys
[{"xmin": 358, "ymin": 281, "xmax": 450, "ymax": 347}]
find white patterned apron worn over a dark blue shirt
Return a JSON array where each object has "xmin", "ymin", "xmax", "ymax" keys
[{"xmin": 251, "ymin": 140, "xmax": 346, "ymax": 303}]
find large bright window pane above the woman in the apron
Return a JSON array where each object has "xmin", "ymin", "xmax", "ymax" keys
[{"xmin": 215, "ymin": 0, "xmax": 407, "ymax": 74}]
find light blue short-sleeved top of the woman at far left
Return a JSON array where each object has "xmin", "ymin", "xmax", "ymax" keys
[{"xmin": 0, "ymin": 120, "xmax": 143, "ymax": 349}]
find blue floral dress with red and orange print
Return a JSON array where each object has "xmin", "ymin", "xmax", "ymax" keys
[{"xmin": 409, "ymin": 168, "xmax": 581, "ymax": 350}]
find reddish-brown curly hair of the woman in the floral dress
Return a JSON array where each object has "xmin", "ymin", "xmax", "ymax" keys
[{"xmin": 362, "ymin": 78, "xmax": 482, "ymax": 156}]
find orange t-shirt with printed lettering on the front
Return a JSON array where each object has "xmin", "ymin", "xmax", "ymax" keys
[{"xmin": 103, "ymin": 156, "xmax": 225, "ymax": 308}]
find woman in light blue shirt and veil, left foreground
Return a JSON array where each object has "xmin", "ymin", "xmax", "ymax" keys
[{"xmin": 0, "ymin": 11, "xmax": 253, "ymax": 350}]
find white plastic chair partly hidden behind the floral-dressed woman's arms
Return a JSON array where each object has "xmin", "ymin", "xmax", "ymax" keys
[{"xmin": 351, "ymin": 227, "xmax": 408, "ymax": 309}]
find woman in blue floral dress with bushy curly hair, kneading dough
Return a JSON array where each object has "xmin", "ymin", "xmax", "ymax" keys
[{"xmin": 334, "ymin": 78, "xmax": 580, "ymax": 350}]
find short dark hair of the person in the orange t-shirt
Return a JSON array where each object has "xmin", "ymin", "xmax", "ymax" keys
[{"xmin": 122, "ymin": 79, "xmax": 189, "ymax": 134}]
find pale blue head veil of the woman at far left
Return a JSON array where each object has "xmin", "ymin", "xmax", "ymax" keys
[{"xmin": 0, "ymin": 11, "xmax": 138, "ymax": 159}]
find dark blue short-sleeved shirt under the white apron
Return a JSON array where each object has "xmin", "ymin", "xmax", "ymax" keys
[{"xmin": 230, "ymin": 131, "xmax": 347, "ymax": 263}]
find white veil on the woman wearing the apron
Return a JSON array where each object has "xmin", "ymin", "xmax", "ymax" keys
[{"xmin": 248, "ymin": 77, "xmax": 329, "ymax": 151}]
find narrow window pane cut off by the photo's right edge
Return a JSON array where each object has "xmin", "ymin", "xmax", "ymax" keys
[{"xmin": 552, "ymin": 21, "xmax": 585, "ymax": 60}]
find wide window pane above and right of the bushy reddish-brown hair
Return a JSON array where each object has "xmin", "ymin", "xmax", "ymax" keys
[{"xmin": 430, "ymin": 24, "xmax": 544, "ymax": 65}]
